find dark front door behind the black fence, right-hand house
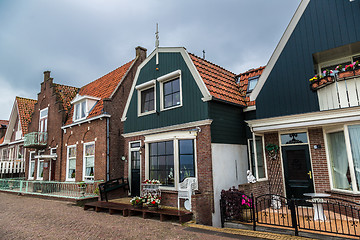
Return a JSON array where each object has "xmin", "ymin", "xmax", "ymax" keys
[{"xmin": 282, "ymin": 145, "xmax": 314, "ymax": 198}]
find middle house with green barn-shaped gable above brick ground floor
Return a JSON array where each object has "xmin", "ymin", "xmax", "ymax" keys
[{"xmin": 122, "ymin": 47, "xmax": 247, "ymax": 226}]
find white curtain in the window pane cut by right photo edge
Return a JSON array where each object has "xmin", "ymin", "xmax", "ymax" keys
[{"xmin": 349, "ymin": 125, "xmax": 360, "ymax": 188}]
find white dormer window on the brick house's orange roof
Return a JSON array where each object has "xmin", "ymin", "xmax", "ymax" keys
[{"xmin": 71, "ymin": 95, "xmax": 100, "ymax": 122}]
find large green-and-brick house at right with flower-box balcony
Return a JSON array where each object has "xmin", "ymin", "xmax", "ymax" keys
[{"xmin": 246, "ymin": 0, "xmax": 360, "ymax": 202}]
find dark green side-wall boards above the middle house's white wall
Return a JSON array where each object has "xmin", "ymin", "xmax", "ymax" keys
[{"xmin": 209, "ymin": 101, "xmax": 246, "ymax": 144}]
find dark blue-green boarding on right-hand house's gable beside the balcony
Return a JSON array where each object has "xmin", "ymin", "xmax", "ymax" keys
[{"xmin": 256, "ymin": 0, "xmax": 360, "ymax": 118}]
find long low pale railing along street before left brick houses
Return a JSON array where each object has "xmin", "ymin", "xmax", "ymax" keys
[{"xmin": 0, "ymin": 179, "xmax": 102, "ymax": 199}]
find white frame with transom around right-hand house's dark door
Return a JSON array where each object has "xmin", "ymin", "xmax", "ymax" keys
[{"xmin": 278, "ymin": 128, "xmax": 316, "ymax": 197}]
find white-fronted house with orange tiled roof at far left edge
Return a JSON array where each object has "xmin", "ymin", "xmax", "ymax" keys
[{"xmin": 0, "ymin": 97, "xmax": 36, "ymax": 178}]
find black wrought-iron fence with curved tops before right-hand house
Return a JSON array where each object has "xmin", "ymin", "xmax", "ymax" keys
[{"xmin": 220, "ymin": 189, "xmax": 360, "ymax": 237}]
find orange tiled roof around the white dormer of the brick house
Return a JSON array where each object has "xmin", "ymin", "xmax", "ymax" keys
[{"xmin": 65, "ymin": 60, "xmax": 134, "ymax": 125}]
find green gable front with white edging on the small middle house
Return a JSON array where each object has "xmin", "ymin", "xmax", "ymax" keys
[{"xmin": 122, "ymin": 48, "xmax": 211, "ymax": 133}]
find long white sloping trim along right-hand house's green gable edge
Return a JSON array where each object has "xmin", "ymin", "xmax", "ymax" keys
[{"xmin": 250, "ymin": 0, "xmax": 310, "ymax": 101}]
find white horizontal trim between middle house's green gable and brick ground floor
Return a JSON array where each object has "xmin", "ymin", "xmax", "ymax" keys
[{"xmin": 122, "ymin": 119, "xmax": 213, "ymax": 138}]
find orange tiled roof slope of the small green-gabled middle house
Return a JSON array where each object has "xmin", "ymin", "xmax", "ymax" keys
[{"xmin": 189, "ymin": 53, "xmax": 246, "ymax": 106}]
